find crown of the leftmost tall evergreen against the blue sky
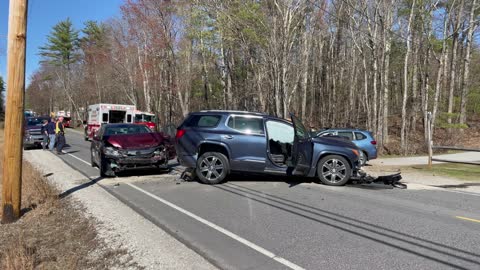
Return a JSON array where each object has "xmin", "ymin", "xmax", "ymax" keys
[{"xmin": 40, "ymin": 18, "xmax": 80, "ymax": 69}]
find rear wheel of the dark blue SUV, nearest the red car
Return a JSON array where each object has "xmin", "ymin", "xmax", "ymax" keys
[{"xmin": 195, "ymin": 152, "xmax": 230, "ymax": 185}]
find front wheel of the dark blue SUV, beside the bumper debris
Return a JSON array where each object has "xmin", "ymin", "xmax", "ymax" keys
[{"xmin": 317, "ymin": 155, "xmax": 352, "ymax": 186}]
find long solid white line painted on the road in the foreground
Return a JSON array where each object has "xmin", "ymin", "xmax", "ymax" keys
[{"xmin": 126, "ymin": 183, "xmax": 304, "ymax": 270}]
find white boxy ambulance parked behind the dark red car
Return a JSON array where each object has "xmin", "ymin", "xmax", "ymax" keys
[{"xmin": 85, "ymin": 103, "xmax": 136, "ymax": 141}]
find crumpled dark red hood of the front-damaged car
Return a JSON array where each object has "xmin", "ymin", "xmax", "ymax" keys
[{"xmin": 105, "ymin": 133, "xmax": 168, "ymax": 149}]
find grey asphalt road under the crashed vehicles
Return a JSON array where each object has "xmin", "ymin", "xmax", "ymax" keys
[{"xmin": 53, "ymin": 132, "xmax": 480, "ymax": 269}]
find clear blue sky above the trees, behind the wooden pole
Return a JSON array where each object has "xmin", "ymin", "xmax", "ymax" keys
[{"xmin": 0, "ymin": 0, "xmax": 125, "ymax": 81}]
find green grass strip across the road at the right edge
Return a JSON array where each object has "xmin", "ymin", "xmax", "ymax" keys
[{"xmin": 408, "ymin": 163, "xmax": 480, "ymax": 181}]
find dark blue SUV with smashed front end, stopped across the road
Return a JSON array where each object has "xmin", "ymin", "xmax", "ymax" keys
[{"xmin": 176, "ymin": 111, "xmax": 359, "ymax": 186}]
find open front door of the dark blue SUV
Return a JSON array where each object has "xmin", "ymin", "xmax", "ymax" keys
[{"xmin": 289, "ymin": 113, "xmax": 313, "ymax": 176}]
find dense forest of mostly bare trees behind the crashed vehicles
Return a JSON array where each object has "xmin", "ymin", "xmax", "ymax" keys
[{"xmin": 27, "ymin": 0, "xmax": 480, "ymax": 154}]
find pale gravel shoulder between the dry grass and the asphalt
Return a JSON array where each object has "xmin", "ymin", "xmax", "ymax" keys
[{"xmin": 24, "ymin": 150, "xmax": 216, "ymax": 269}]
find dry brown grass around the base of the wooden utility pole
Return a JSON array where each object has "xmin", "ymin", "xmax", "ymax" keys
[{"xmin": 0, "ymin": 130, "xmax": 137, "ymax": 270}]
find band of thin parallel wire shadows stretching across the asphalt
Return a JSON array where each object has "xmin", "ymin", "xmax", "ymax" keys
[{"xmin": 215, "ymin": 183, "xmax": 480, "ymax": 269}]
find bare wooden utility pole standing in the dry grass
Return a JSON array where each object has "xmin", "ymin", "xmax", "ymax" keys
[{"xmin": 2, "ymin": 0, "xmax": 28, "ymax": 223}]
